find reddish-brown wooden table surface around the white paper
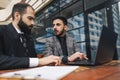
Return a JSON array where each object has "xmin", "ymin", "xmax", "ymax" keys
[{"xmin": 0, "ymin": 60, "xmax": 120, "ymax": 80}]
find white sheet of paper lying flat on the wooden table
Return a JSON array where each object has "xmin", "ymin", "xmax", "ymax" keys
[{"xmin": 0, "ymin": 66, "xmax": 78, "ymax": 80}]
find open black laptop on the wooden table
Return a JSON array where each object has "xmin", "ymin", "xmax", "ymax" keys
[{"xmin": 67, "ymin": 26, "xmax": 117, "ymax": 66}]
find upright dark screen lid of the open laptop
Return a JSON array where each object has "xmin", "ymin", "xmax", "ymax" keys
[{"xmin": 95, "ymin": 26, "xmax": 117, "ymax": 64}]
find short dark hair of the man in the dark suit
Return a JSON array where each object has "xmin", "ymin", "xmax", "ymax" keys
[{"xmin": 12, "ymin": 3, "xmax": 34, "ymax": 20}]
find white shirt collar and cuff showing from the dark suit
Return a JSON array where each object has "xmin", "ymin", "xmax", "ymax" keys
[{"xmin": 14, "ymin": 27, "xmax": 39, "ymax": 67}]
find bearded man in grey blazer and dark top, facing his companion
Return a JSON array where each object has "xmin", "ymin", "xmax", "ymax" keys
[{"xmin": 46, "ymin": 16, "xmax": 88, "ymax": 63}]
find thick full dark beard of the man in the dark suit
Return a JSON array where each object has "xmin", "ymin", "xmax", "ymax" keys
[{"xmin": 18, "ymin": 18, "xmax": 33, "ymax": 35}]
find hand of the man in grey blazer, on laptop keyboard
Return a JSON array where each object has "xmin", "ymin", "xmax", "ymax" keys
[{"xmin": 68, "ymin": 52, "xmax": 88, "ymax": 61}]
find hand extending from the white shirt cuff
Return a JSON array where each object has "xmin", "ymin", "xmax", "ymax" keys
[{"xmin": 38, "ymin": 55, "xmax": 61, "ymax": 66}]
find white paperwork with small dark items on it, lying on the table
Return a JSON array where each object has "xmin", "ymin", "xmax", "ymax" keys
[{"xmin": 0, "ymin": 66, "xmax": 79, "ymax": 80}]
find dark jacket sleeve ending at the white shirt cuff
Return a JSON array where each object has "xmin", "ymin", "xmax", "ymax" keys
[{"xmin": 0, "ymin": 28, "xmax": 29, "ymax": 70}]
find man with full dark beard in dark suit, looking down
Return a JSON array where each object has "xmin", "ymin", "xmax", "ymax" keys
[{"xmin": 0, "ymin": 3, "xmax": 61, "ymax": 69}]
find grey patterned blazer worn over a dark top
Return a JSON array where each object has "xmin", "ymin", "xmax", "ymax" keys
[{"xmin": 46, "ymin": 34, "xmax": 80, "ymax": 58}]
